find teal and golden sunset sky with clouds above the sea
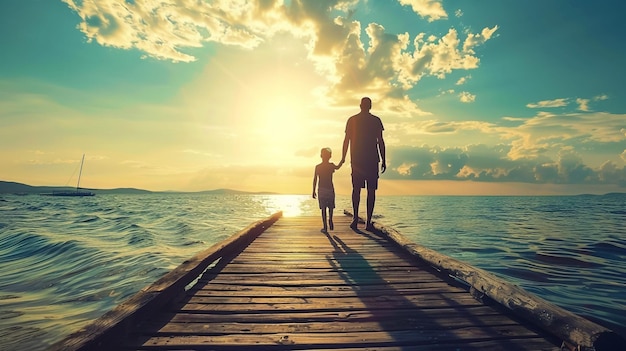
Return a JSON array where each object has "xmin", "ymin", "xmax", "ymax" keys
[{"xmin": 0, "ymin": 0, "xmax": 626, "ymax": 195}]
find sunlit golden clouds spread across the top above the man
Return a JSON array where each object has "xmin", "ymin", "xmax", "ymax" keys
[{"xmin": 63, "ymin": 0, "xmax": 497, "ymax": 116}]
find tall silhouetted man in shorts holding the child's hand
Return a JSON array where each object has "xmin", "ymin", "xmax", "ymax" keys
[{"xmin": 339, "ymin": 97, "xmax": 387, "ymax": 230}]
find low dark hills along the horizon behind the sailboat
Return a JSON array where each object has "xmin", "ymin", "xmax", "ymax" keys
[{"xmin": 0, "ymin": 180, "xmax": 276, "ymax": 195}]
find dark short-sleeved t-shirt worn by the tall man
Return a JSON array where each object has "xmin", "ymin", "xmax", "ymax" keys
[{"xmin": 346, "ymin": 113, "xmax": 384, "ymax": 167}]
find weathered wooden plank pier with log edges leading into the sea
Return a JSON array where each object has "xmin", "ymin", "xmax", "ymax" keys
[{"xmin": 51, "ymin": 213, "xmax": 622, "ymax": 351}]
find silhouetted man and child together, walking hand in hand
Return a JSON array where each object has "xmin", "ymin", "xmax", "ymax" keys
[{"xmin": 313, "ymin": 97, "xmax": 387, "ymax": 233}]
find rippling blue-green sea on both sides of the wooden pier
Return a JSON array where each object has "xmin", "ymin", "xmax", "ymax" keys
[{"xmin": 0, "ymin": 194, "xmax": 626, "ymax": 350}]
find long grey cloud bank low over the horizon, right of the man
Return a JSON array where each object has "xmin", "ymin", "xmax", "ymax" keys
[{"xmin": 386, "ymin": 144, "xmax": 626, "ymax": 187}]
